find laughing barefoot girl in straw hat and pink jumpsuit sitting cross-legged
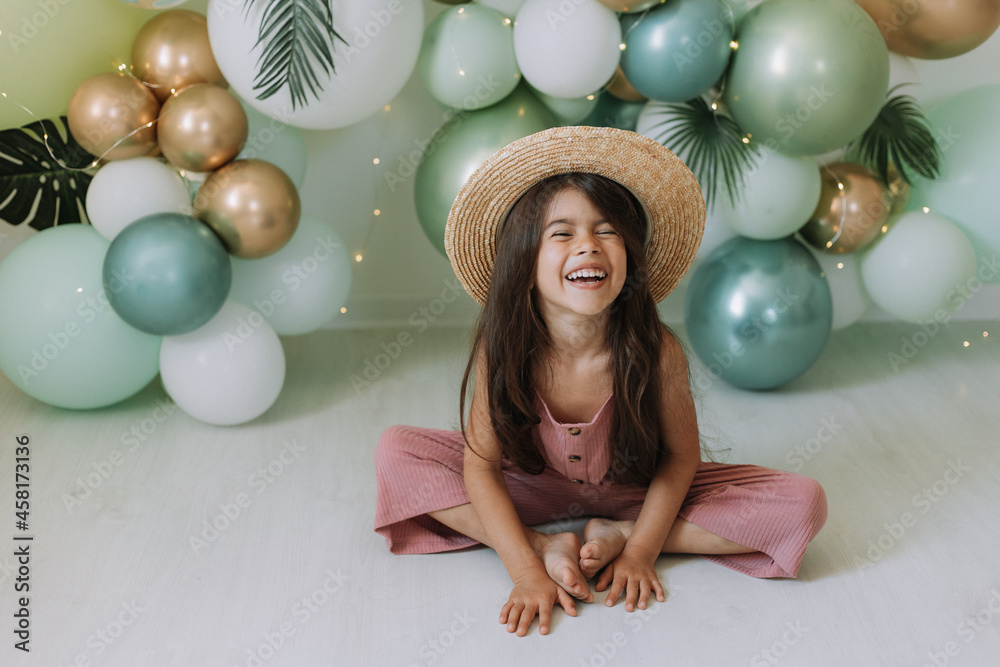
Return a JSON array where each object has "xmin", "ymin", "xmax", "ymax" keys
[{"xmin": 375, "ymin": 127, "xmax": 826, "ymax": 636}]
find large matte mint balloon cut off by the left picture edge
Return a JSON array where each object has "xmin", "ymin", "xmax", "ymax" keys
[{"xmin": 0, "ymin": 225, "xmax": 162, "ymax": 410}]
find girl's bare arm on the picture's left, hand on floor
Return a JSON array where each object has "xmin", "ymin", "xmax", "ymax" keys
[{"xmin": 463, "ymin": 355, "xmax": 576, "ymax": 636}]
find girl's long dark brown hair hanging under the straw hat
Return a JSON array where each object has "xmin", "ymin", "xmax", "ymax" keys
[{"xmin": 459, "ymin": 173, "xmax": 669, "ymax": 486}]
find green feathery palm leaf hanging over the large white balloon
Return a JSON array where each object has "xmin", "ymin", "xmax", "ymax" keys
[{"xmin": 244, "ymin": 0, "xmax": 347, "ymax": 111}]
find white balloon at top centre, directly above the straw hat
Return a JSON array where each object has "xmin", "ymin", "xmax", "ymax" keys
[{"xmin": 514, "ymin": 0, "xmax": 622, "ymax": 98}]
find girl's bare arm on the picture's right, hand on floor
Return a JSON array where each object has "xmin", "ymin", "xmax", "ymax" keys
[{"xmin": 597, "ymin": 332, "xmax": 701, "ymax": 611}]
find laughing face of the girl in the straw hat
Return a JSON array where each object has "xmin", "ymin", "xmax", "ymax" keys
[{"xmin": 533, "ymin": 188, "xmax": 628, "ymax": 315}]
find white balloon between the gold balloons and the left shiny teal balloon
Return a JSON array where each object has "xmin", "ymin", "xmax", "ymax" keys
[{"xmin": 87, "ymin": 157, "xmax": 191, "ymax": 241}]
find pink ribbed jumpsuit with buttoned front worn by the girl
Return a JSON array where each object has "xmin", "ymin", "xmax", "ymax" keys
[{"xmin": 375, "ymin": 394, "xmax": 826, "ymax": 577}]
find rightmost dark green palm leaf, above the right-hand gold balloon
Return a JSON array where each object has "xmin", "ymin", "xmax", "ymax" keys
[{"xmin": 851, "ymin": 88, "xmax": 941, "ymax": 183}]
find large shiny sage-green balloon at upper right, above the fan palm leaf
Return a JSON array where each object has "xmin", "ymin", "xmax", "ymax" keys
[{"xmin": 724, "ymin": 0, "xmax": 889, "ymax": 155}]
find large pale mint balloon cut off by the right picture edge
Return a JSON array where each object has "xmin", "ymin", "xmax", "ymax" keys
[{"xmin": 907, "ymin": 85, "xmax": 1000, "ymax": 283}]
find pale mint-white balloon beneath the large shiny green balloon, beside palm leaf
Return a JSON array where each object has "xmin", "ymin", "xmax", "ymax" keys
[{"xmin": 718, "ymin": 147, "xmax": 821, "ymax": 240}]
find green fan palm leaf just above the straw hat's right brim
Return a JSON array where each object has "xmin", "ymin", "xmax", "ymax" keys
[{"xmin": 650, "ymin": 97, "xmax": 758, "ymax": 208}]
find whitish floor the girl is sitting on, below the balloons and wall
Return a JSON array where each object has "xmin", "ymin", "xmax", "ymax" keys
[{"xmin": 0, "ymin": 322, "xmax": 1000, "ymax": 667}]
